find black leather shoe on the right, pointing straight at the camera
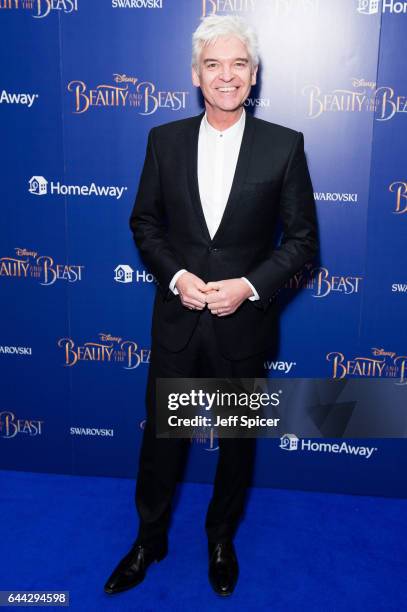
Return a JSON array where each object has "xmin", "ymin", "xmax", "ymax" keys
[{"xmin": 209, "ymin": 540, "xmax": 239, "ymax": 595}]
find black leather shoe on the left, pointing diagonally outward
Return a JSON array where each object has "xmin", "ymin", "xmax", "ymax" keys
[{"xmin": 104, "ymin": 541, "xmax": 168, "ymax": 595}]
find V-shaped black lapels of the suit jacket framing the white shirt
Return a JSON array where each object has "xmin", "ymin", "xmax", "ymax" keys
[{"xmin": 187, "ymin": 112, "xmax": 254, "ymax": 243}]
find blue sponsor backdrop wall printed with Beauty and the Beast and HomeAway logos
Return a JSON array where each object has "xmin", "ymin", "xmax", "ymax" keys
[{"xmin": 0, "ymin": 0, "xmax": 407, "ymax": 496}]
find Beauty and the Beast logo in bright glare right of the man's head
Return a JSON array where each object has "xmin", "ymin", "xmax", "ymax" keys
[{"xmin": 301, "ymin": 78, "xmax": 407, "ymax": 121}]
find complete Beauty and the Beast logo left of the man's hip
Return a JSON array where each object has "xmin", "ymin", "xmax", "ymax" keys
[{"xmin": 57, "ymin": 333, "xmax": 150, "ymax": 370}]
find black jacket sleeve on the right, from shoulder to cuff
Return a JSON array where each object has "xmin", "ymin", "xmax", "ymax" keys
[{"xmin": 246, "ymin": 132, "xmax": 318, "ymax": 310}]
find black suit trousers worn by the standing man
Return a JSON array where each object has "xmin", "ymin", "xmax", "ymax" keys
[{"xmin": 135, "ymin": 308, "xmax": 265, "ymax": 544}]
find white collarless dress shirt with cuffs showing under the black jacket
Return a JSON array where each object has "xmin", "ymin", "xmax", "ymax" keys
[{"xmin": 170, "ymin": 109, "xmax": 260, "ymax": 301}]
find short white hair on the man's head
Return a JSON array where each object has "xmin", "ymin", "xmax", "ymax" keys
[{"xmin": 192, "ymin": 15, "xmax": 259, "ymax": 72}]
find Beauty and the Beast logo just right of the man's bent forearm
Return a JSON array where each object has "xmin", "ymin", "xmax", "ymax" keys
[{"xmin": 284, "ymin": 264, "xmax": 363, "ymax": 298}]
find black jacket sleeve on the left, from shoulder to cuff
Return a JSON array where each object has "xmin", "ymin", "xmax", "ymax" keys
[{"xmin": 129, "ymin": 128, "xmax": 184, "ymax": 299}]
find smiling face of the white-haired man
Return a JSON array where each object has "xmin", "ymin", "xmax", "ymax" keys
[{"xmin": 192, "ymin": 36, "xmax": 257, "ymax": 121}]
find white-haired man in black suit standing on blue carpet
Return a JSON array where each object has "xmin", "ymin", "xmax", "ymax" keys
[{"xmin": 105, "ymin": 15, "xmax": 317, "ymax": 595}]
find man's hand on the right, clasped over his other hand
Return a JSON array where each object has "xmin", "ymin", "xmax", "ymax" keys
[{"xmin": 203, "ymin": 278, "xmax": 253, "ymax": 317}]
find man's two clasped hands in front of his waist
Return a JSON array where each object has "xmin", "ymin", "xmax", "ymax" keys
[{"xmin": 175, "ymin": 272, "xmax": 253, "ymax": 317}]
